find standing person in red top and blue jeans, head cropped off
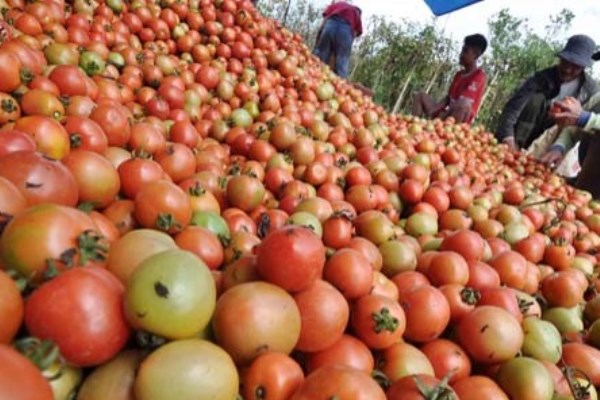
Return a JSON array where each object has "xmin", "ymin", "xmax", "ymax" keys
[{"xmin": 314, "ymin": 0, "xmax": 362, "ymax": 78}]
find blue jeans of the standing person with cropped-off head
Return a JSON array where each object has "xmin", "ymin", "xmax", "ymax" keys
[{"xmin": 315, "ymin": 17, "xmax": 354, "ymax": 78}]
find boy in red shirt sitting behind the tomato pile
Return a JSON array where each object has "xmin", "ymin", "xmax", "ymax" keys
[{"xmin": 412, "ymin": 34, "xmax": 487, "ymax": 124}]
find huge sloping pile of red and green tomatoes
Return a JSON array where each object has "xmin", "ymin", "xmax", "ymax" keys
[{"xmin": 0, "ymin": 0, "xmax": 600, "ymax": 400}]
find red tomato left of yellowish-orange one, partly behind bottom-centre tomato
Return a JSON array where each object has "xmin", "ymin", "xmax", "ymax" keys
[{"xmin": 306, "ymin": 334, "xmax": 375, "ymax": 374}]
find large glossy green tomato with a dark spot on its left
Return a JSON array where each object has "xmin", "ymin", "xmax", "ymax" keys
[{"xmin": 125, "ymin": 250, "xmax": 217, "ymax": 339}]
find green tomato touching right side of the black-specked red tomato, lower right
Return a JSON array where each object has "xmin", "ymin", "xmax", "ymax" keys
[{"xmin": 521, "ymin": 317, "xmax": 562, "ymax": 364}]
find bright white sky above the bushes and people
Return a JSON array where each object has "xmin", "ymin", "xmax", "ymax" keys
[{"xmin": 315, "ymin": 0, "xmax": 600, "ymax": 76}]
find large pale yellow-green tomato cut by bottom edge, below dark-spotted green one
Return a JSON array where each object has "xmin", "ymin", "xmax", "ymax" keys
[{"xmin": 134, "ymin": 339, "xmax": 239, "ymax": 400}]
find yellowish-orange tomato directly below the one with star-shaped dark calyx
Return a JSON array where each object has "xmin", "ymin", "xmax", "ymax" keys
[{"xmin": 377, "ymin": 342, "xmax": 435, "ymax": 383}]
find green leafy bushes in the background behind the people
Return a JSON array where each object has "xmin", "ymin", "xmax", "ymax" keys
[{"xmin": 259, "ymin": 0, "xmax": 574, "ymax": 129}]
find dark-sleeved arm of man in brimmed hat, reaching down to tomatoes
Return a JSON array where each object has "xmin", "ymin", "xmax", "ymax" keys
[{"xmin": 496, "ymin": 76, "xmax": 539, "ymax": 148}]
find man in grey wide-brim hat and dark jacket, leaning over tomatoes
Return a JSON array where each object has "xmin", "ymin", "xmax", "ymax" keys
[{"xmin": 496, "ymin": 35, "xmax": 598, "ymax": 149}]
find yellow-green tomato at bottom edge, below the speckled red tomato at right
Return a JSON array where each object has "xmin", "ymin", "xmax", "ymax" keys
[{"xmin": 497, "ymin": 357, "xmax": 554, "ymax": 400}]
